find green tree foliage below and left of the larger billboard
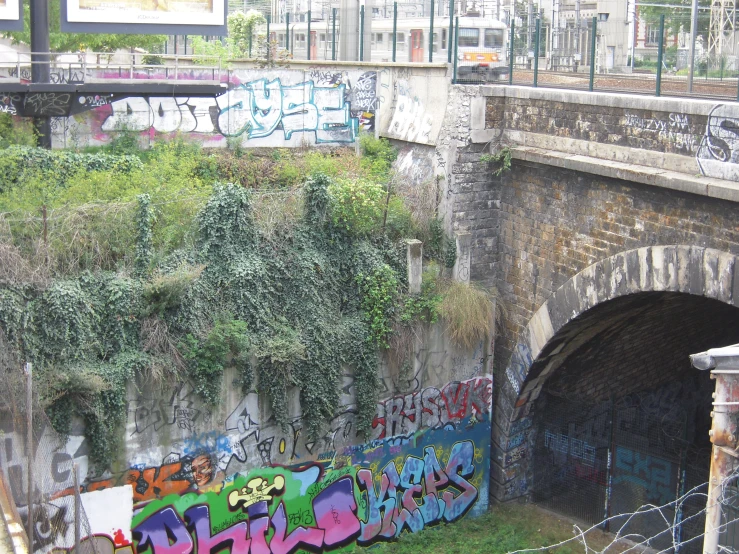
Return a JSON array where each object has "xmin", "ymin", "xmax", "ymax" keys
[{"xmin": 5, "ymin": 0, "xmax": 167, "ymax": 52}]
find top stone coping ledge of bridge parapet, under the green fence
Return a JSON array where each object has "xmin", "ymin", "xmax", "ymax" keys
[{"xmin": 480, "ymin": 85, "xmax": 739, "ymax": 116}]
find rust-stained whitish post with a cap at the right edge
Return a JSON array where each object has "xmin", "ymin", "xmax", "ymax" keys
[{"xmin": 690, "ymin": 344, "xmax": 739, "ymax": 554}]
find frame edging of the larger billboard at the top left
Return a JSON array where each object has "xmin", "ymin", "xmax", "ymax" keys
[{"xmin": 60, "ymin": 0, "xmax": 228, "ymax": 36}]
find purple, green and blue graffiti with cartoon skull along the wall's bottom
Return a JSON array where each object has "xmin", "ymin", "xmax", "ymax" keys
[{"xmin": 132, "ymin": 422, "xmax": 489, "ymax": 554}]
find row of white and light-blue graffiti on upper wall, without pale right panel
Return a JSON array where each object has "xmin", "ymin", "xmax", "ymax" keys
[{"xmin": 52, "ymin": 69, "xmax": 377, "ymax": 146}]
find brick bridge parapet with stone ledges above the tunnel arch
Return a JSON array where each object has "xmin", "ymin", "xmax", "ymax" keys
[{"xmin": 471, "ymin": 86, "xmax": 739, "ymax": 201}]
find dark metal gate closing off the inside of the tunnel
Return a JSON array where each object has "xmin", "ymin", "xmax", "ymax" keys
[{"xmin": 533, "ymin": 383, "xmax": 710, "ymax": 553}]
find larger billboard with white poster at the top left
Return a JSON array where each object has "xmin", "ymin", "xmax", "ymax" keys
[{"xmin": 60, "ymin": 0, "xmax": 228, "ymax": 36}]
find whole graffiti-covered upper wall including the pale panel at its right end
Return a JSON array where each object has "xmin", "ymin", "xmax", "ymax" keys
[{"xmin": 47, "ymin": 62, "xmax": 448, "ymax": 148}]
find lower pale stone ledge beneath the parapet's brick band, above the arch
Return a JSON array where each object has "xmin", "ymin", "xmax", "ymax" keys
[{"xmin": 511, "ymin": 146, "xmax": 739, "ymax": 202}]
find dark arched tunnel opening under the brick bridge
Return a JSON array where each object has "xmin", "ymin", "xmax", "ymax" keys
[{"xmin": 532, "ymin": 292, "xmax": 739, "ymax": 552}]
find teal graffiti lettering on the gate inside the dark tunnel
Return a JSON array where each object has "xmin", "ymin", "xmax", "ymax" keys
[{"xmin": 613, "ymin": 446, "xmax": 676, "ymax": 505}]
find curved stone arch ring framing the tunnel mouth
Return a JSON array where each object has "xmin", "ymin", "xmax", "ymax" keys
[{"xmin": 491, "ymin": 245, "xmax": 739, "ymax": 500}]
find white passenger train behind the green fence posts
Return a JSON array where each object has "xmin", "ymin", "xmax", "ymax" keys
[{"xmin": 270, "ymin": 14, "xmax": 508, "ymax": 82}]
